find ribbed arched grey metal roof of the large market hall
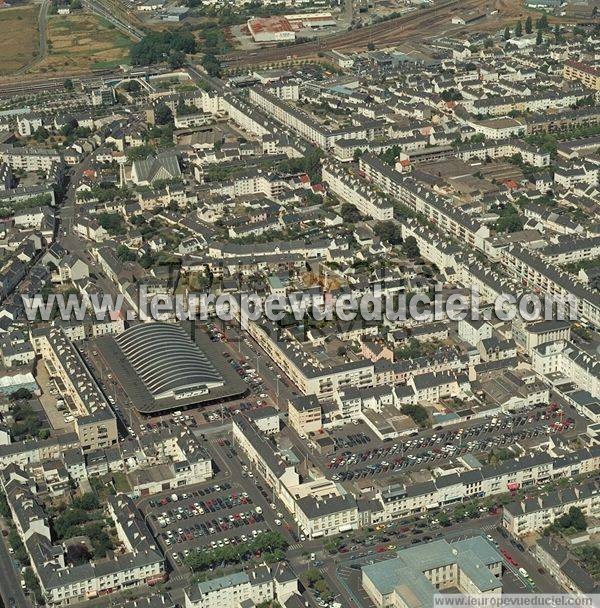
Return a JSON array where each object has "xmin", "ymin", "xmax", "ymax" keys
[{"xmin": 115, "ymin": 322, "xmax": 223, "ymax": 399}]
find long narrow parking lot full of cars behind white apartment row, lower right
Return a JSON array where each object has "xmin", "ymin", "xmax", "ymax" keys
[{"xmin": 317, "ymin": 406, "xmax": 575, "ymax": 481}]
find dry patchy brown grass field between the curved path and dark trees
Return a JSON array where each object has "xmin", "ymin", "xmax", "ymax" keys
[{"xmin": 33, "ymin": 11, "xmax": 132, "ymax": 73}]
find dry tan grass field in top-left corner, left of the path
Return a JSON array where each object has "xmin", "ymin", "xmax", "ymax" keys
[{"xmin": 0, "ymin": 6, "xmax": 40, "ymax": 76}]
